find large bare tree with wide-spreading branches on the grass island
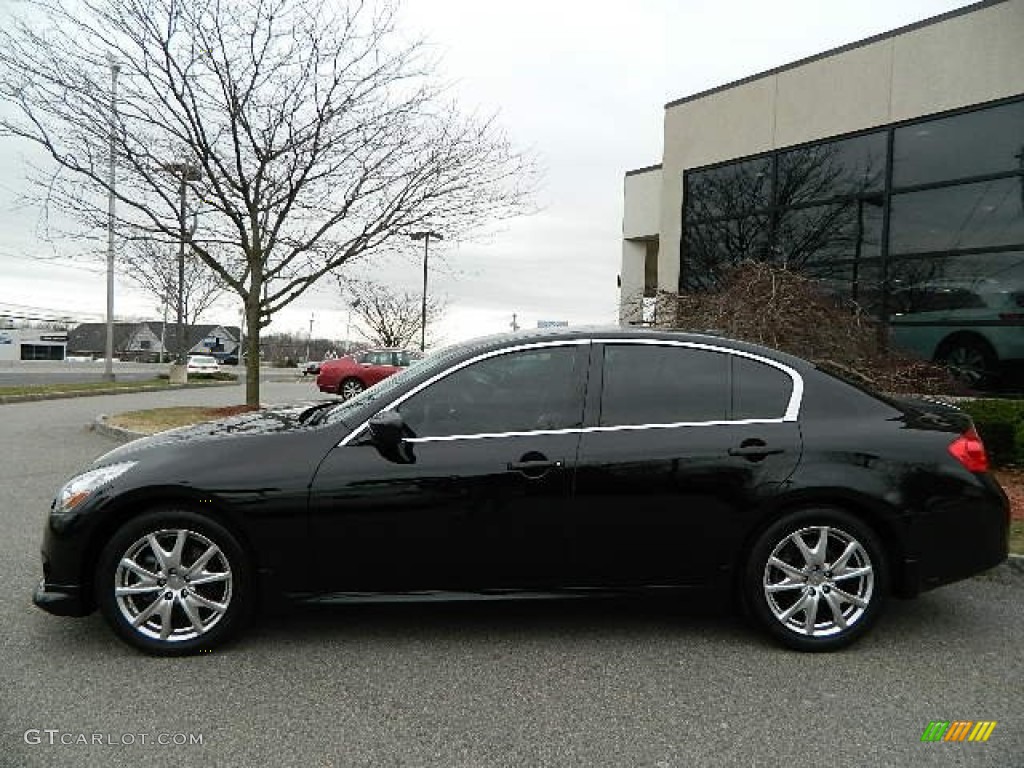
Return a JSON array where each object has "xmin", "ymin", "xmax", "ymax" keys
[{"xmin": 0, "ymin": 0, "xmax": 537, "ymax": 403}]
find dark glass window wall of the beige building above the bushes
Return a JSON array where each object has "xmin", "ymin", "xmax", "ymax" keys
[{"xmin": 679, "ymin": 98, "xmax": 1024, "ymax": 380}]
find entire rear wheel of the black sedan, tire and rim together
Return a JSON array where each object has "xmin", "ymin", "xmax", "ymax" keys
[{"xmin": 742, "ymin": 508, "xmax": 889, "ymax": 651}]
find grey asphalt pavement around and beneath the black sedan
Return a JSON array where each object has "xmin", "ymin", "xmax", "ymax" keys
[{"xmin": 0, "ymin": 382, "xmax": 1024, "ymax": 768}]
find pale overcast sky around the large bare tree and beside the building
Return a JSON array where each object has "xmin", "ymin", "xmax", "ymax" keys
[{"xmin": 0, "ymin": 0, "xmax": 971, "ymax": 342}]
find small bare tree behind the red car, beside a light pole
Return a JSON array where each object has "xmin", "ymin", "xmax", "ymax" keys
[{"xmin": 345, "ymin": 281, "xmax": 447, "ymax": 347}]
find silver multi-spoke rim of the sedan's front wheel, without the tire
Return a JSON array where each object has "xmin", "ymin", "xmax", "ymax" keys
[{"xmin": 114, "ymin": 528, "xmax": 232, "ymax": 642}]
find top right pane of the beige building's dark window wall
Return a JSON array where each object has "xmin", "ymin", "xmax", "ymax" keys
[{"xmin": 893, "ymin": 102, "xmax": 1024, "ymax": 187}]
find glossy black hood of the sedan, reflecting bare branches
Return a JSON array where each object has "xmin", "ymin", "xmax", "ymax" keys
[{"xmin": 93, "ymin": 403, "xmax": 327, "ymax": 466}]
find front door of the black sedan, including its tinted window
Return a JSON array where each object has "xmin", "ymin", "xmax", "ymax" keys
[{"xmin": 310, "ymin": 341, "xmax": 590, "ymax": 592}]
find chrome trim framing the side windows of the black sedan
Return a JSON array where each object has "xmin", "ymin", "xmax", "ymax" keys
[{"xmin": 338, "ymin": 338, "xmax": 804, "ymax": 447}]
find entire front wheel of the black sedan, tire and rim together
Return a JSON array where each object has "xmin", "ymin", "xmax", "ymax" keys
[{"xmin": 94, "ymin": 508, "xmax": 255, "ymax": 656}]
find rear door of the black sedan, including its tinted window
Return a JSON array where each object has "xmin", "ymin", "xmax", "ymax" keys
[{"xmin": 569, "ymin": 341, "xmax": 801, "ymax": 586}]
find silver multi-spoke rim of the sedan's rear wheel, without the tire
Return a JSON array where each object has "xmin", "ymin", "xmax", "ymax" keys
[{"xmin": 762, "ymin": 525, "xmax": 874, "ymax": 637}]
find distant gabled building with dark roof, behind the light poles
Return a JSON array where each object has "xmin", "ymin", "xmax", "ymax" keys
[{"xmin": 68, "ymin": 321, "xmax": 241, "ymax": 362}]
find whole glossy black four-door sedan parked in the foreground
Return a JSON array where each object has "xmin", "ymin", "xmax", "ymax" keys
[{"xmin": 35, "ymin": 329, "xmax": 1010, "ymax": 654}]
